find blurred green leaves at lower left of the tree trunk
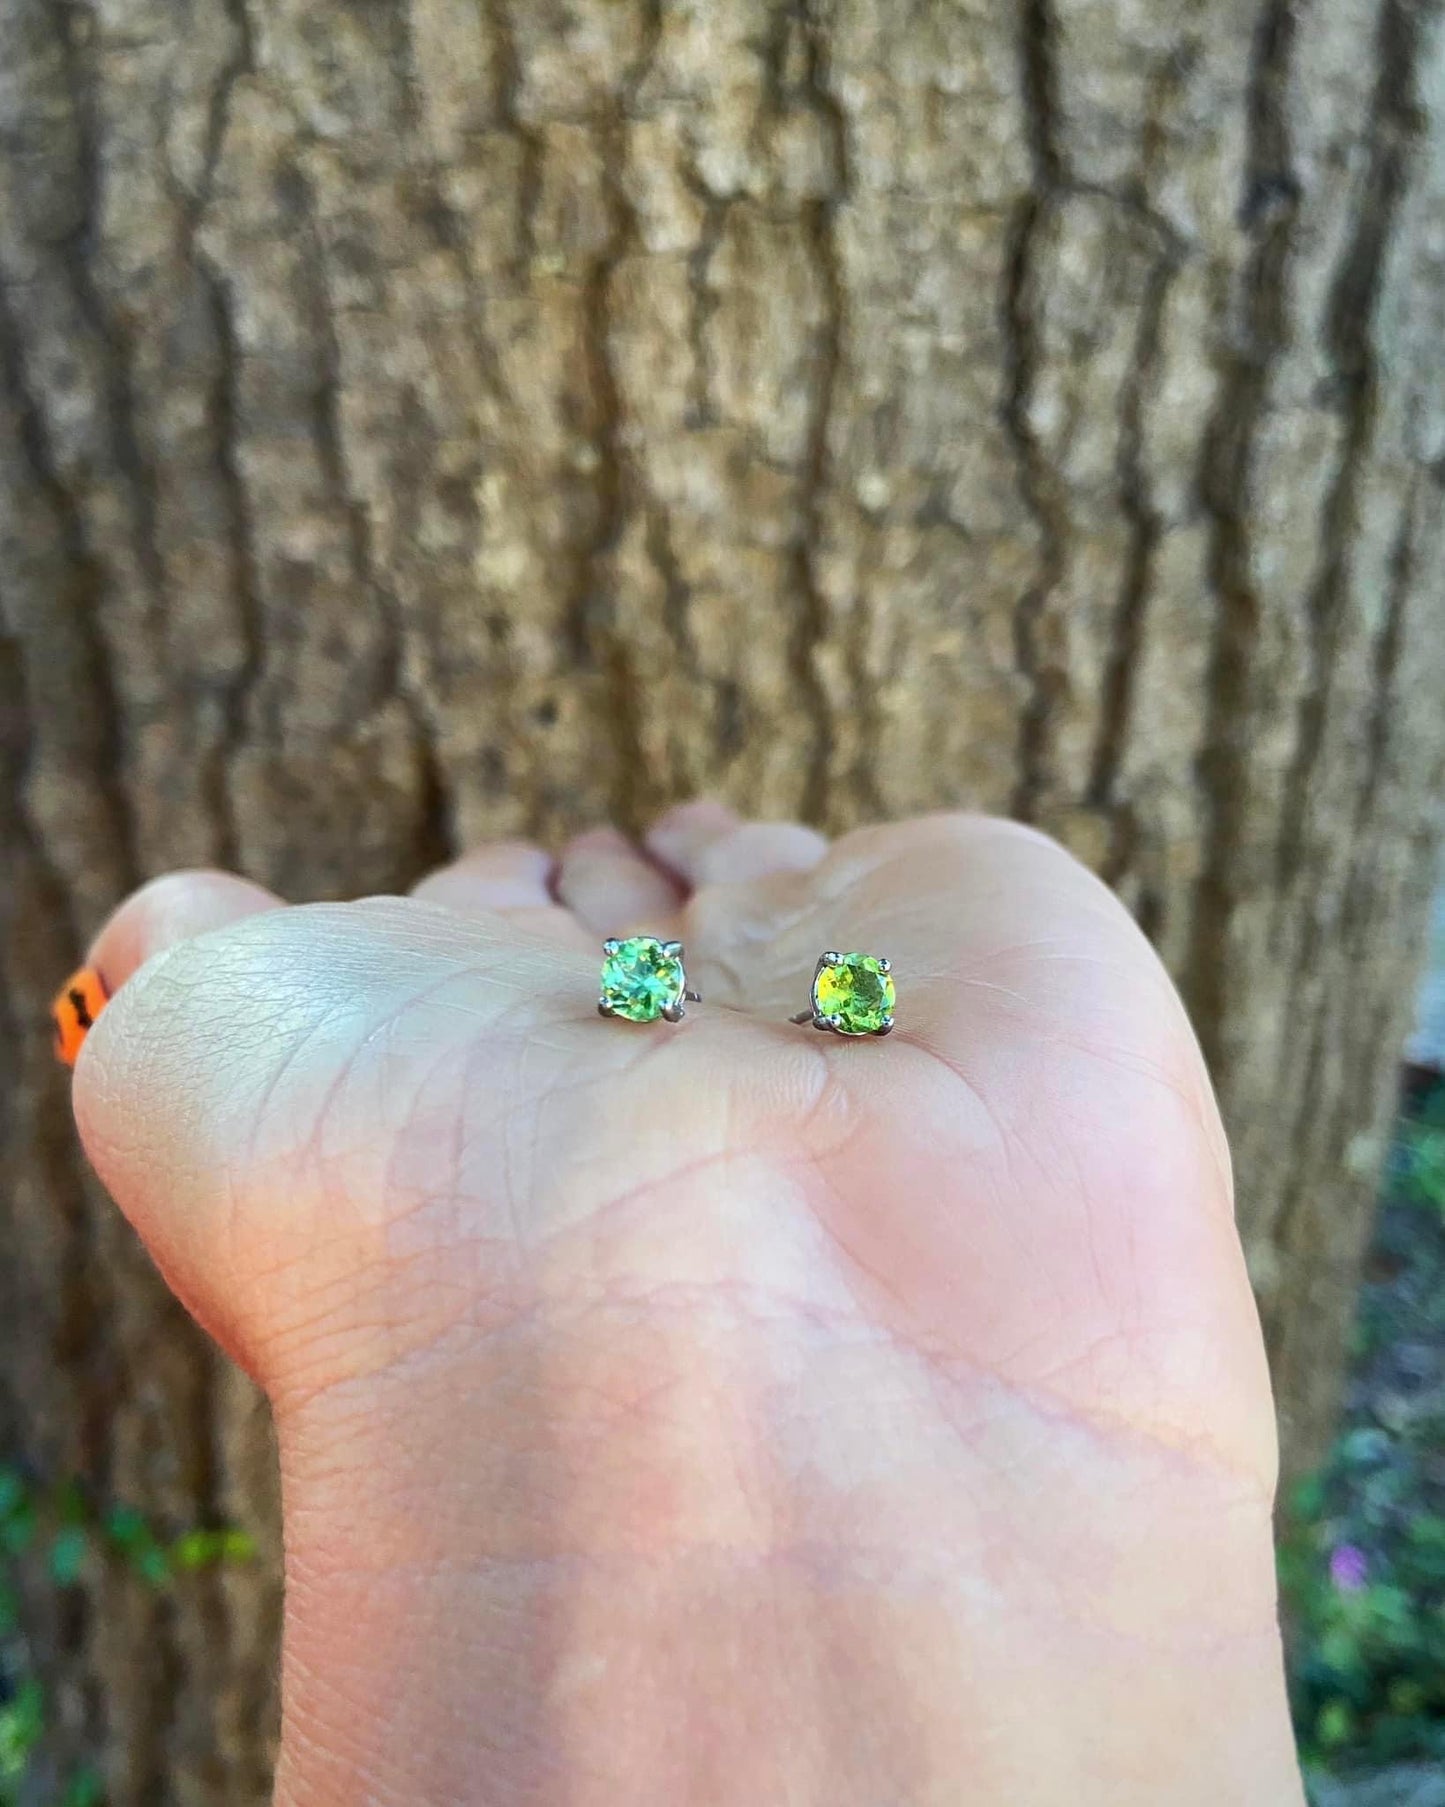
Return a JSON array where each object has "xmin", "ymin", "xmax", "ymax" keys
[{"xmin": 0, "ymin": 1465, "xmax": 255, "ymax": 1807}]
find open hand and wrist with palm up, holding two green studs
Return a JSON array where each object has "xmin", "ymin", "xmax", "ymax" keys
[{"xmin": 76, "ymin": 804, "xmax": 1301, "ymax": 1807}]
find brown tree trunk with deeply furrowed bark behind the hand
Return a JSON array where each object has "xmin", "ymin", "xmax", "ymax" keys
[{"xmin": 0, "ymin": 0, "xmax": 1445, "ymax": 1807}]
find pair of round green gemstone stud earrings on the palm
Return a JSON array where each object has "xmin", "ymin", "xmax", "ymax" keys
[{"xmin": 598, "ymin": 934, "xmax": 898, "ymax": 1035}]
